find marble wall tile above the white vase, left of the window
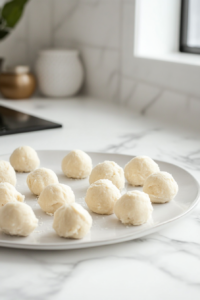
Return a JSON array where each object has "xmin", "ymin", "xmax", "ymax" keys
[{"xmin": 54, "ymin": 0, "xmax": 120, "ymax": 51}]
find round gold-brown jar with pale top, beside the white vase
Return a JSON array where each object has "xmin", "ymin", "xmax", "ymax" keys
[{"xmin": 0, "ymin": 66, "xmax": 36, "ymax": 100}]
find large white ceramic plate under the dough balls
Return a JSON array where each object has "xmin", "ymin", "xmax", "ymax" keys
[{"xmin": 0, "ymin": 151, "xmax": 199, "ymax": 250}]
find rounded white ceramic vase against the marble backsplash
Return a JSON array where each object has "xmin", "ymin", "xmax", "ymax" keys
[{"xmin": 36, "ymin": 50, "xmax": 84, "ymax": 97}]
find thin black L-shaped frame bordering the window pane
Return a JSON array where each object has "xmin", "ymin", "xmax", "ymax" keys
[{"xmin": 179, "ymin": 0, "xmax": 200, "ymax": 54}]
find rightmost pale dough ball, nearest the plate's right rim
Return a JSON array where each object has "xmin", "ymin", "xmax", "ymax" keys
[{"xmin": 143, "ymin": 172, "xmax": 178, "ymax": 203}]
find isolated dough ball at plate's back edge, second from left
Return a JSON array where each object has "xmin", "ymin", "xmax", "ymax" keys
[{"xmin": 62, "ymin": 150, "xmax": 92, "ymax": 179}]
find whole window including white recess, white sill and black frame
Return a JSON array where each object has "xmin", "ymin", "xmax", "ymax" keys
[{"xmin": 133, "ymin": 0, "xmax": 200, "ymax": 66}]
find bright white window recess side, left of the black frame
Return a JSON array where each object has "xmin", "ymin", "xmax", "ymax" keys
[{"xmin": 134, "ymin": 0, "xmax": 181, "ymax": 58}]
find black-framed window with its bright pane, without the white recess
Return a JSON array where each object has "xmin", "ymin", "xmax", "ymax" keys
[{"xmin": 180, "ymin": 0, "xmax": 200, "ymax": 54}]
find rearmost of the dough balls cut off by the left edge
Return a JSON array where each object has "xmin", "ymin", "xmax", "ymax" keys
[{"xmin": 0, "ymin": 160, "xmax": 17, "ymax": 186}]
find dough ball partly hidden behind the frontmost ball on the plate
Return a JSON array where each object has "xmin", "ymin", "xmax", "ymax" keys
[{"xmin": 38, "ymin": 183, "xmax": 75, "ymax": 214}]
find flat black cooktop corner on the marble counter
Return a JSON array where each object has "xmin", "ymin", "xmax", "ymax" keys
[{"xmin": 0, "ymin": 105, "xmax": 62, "ymax": 135}]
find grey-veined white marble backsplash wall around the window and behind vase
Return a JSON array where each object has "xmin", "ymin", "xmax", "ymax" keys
[{"xmin": 0, "ymin": 0, "xmax": 200, "ymax": 126}]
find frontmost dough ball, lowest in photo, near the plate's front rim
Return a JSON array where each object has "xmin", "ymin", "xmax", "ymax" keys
[{"xmin": 53, "ymin": 203, "xmax": 92, "ymax": 239}]
